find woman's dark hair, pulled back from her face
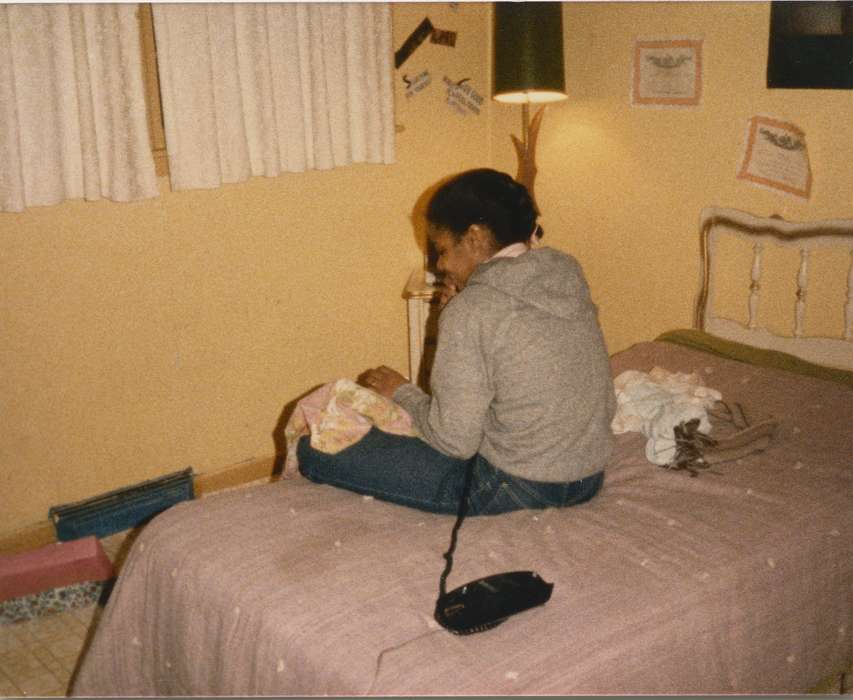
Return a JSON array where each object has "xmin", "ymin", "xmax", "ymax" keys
[{"xmin": 426, "ymin": 168, "xmax": 541, "ymax": 248}]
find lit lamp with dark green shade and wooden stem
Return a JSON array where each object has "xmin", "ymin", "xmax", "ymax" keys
[{"xmin": 492, "ymin": 2, "xmax": 568, "ymax": 210}]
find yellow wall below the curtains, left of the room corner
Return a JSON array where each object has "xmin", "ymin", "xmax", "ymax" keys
[{"xmin": 0, "ymin": 4, "xmax": 489, "ymax": 536}]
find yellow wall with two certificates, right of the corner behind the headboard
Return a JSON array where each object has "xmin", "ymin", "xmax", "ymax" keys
[{"xmin": 493, "ymin": 2, "xmax": 853, "ymax": 352}]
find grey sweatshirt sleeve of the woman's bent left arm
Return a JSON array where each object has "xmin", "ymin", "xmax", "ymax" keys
[{"xmin": 394, "ymin": 294, "xmax": 494, "ymax": 458}]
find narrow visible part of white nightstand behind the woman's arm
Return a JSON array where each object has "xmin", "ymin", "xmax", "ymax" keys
[{"xmin": 403, "ymin": 268, "xmax": 438, "ymax": 391}]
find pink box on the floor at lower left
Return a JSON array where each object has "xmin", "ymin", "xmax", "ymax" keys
[{"xmin": 0, "ymin": 536, "xmax": 115, "ymax": 601}]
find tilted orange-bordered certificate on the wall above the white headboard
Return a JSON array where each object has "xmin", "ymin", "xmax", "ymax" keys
[{"xmin": 737, "ymin": 116, "xmax": 812, "ymax": 199}]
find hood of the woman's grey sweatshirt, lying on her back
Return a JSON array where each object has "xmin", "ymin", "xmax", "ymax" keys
[{"xmin": 466, "ymin": 247, "xmax": 596, "ymax": 319}]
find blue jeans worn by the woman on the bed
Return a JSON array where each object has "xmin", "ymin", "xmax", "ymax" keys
[{"xmin": 296, "ymin": 428, "xmax": 604, "ymax": 515}]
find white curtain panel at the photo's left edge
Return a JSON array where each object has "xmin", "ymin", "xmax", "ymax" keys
[{"xmin": 0, "ymin": 4, "xmax": 158, "ymax": 211}]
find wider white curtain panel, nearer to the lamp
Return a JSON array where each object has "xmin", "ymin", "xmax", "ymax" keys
[{"xmin": 153, "ymin": 3, "xmax": 394, "ymax": 189}]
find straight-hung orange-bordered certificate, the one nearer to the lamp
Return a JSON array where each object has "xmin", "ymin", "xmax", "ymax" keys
[{"xmin": 631, "ymin": 39, "xmax": 702, "ymax": 107}]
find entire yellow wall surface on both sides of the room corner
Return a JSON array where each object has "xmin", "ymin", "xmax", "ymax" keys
[{"xmin": 0, "ymin": 2, "xmax": 853, "ymax": 536}]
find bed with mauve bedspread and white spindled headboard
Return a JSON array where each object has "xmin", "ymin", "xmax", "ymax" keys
[{"xmin": 73, "ymin": 208, "xmax": 853, "ymax": 696}]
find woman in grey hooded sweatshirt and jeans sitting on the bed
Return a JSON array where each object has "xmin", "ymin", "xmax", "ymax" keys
[{"xmin": 298, "ymin": 169, "xmax": 615, "ymax": 515}]
